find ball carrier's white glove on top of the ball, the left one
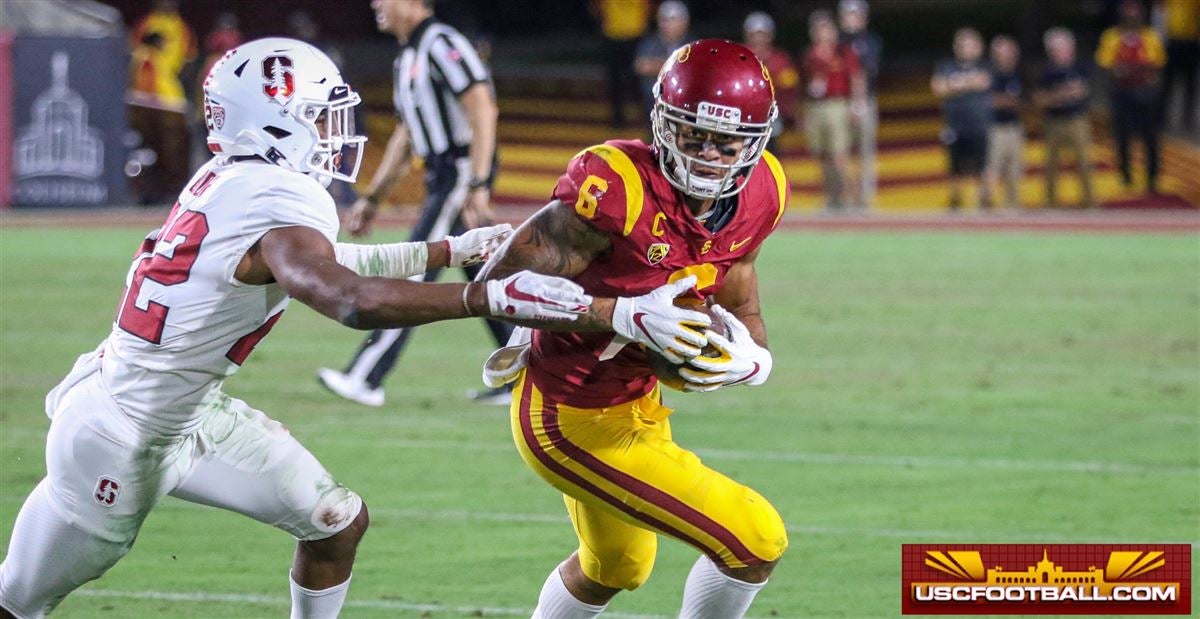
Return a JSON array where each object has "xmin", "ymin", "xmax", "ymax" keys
[{"xmin": 612, "ymin": 276, "xmax": 713, "ymax": 365}]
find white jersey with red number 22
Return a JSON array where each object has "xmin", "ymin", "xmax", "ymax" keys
[{"xmin": 101, "ymin": 160, "xmax": 338, "ymax": 437}]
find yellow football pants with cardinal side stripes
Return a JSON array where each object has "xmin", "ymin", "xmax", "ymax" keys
[{"xmin": 511, "ymin": 375, "xmax": 787, "ymax": 589}]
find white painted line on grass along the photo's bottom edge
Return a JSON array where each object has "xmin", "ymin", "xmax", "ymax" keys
[{"xmin": 72, "ymin": 589, "xmax": 670, "ymax": 619}]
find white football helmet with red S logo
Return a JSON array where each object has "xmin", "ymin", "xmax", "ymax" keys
[{"xmin": 204, "ymin": 37, "xmax": 367, "ymax": 186}]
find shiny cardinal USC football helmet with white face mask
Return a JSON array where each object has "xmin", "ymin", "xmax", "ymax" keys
[{"xmin": 650, "ymin": 38, "xmax": 778, "ymax": 199}]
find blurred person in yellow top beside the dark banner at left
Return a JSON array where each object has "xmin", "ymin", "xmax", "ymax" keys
[{"xmin": 130, "ymin": 0, "xmax": 196, "ymax": 204}]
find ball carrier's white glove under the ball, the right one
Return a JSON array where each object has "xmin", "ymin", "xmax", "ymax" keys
[{"xmin": 679, "ymin": 305, "xmax": 772, "ymax": 391}]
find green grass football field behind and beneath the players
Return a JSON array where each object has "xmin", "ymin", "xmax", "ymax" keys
[{"xmin": 0, "ymin": 227, "xmax": 1200, "ymax": 618}]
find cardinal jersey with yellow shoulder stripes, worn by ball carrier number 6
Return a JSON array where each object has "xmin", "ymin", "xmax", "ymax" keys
[{"xmin": 529, "ymin": 140, "xmax": 790, "ymax": 408}]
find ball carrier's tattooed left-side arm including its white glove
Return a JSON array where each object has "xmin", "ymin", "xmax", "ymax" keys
[{"xmin": 480, "ymin": 200, "xmax": 712, "ymax": 363}]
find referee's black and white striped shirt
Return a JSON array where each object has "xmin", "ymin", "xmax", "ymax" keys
[{"xmin": 392, "ymin": 17, "xmax": 490, "ymax": 158}]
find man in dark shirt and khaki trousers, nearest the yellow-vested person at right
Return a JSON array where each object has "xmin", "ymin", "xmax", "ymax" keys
[{"xmin": 1033, "ymin": 28, "xmax": 1096, "ymax": 209}]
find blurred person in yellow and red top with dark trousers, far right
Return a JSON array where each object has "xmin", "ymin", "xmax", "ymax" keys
[{"xmin": 1096, "ymin": 0, "xmax": 1166, "ymax": 193}]
